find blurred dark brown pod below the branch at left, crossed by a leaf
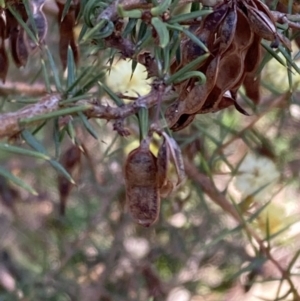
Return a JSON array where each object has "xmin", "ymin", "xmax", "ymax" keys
[{"xmin": 57, "ymin": 145, "xmax": 81, "ymax": 215}]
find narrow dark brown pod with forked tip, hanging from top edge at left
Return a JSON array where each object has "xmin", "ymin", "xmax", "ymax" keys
[{"xmin": 56, "ymin": 1, "xmax": 80, "ymax": 69}]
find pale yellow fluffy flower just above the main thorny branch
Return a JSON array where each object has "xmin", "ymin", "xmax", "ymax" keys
[{"xmin": 106, "ymin": 59, "xmax": 152, "ymax": 101}]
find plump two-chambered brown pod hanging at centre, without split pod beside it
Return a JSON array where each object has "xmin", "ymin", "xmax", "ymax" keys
[{"xmin": 125, "ymin": 139, "xmax": 160, "ymax": 227}]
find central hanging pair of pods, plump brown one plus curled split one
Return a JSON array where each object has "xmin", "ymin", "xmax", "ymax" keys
[{"xmin": 124, "ymin": 125, "xmax": 185, "ymax": 227}]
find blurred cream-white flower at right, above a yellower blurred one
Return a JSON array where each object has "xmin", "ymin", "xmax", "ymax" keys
[{"xmin": 234, "ymin": 153, "xmax": 280, "ymax": 200}]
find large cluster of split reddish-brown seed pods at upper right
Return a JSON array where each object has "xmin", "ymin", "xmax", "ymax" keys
[{"xmin": 165, "ymin": 0, "xmax": 291, "ymax": 131}]
